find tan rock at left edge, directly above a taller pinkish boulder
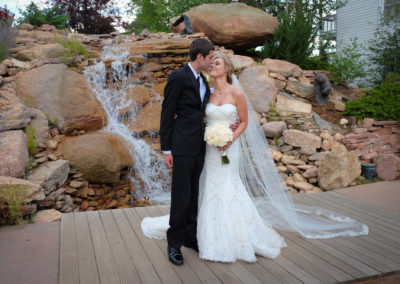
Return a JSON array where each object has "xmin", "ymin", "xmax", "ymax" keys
[{"xmin": 0, "ymin": 90, "xmax": 35, "ymax": 132}]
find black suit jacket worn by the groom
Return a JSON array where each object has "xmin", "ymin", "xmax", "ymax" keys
[{"xmin": 160, "ymin": 64, "xmax": 210, "ymax": 157}]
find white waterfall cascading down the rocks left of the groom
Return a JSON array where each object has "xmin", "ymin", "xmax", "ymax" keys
[{"xmin": 84, "ymin": 37, "xmax": 170, "ymax": 203}]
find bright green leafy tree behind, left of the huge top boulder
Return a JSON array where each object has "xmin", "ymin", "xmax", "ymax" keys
[{"xmin": 124, "ymin": 0, "xmax": 229, "ymax": 33}]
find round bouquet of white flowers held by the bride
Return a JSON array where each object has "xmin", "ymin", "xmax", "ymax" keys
[{"xmin": 204, "ymin": 123, "xmax": 233, "ymax": 165}]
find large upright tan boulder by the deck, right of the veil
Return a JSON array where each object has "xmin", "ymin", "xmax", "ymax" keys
[{"xmin": 318, "ymin": 143, "xmax": 361, "ymax": 190}]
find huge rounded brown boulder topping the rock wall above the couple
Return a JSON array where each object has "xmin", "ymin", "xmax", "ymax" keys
[{"xmin": 170, "ymin": 3, "xmax": 279, "ymax": 50}]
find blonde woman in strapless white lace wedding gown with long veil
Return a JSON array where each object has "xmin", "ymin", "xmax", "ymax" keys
[{"xmin": 141, "ymin": 52, "xmax": 368, "ymax": 262}]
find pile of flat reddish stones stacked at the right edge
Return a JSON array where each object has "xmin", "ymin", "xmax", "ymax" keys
[{"xmin": 342, "ymin": 118, "xmax": 400, "ymax": 163}]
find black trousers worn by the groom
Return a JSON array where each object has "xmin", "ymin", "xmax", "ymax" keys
[{"xmin": 167, "ymin": 154, "xmax": 204, "ymax": 248}]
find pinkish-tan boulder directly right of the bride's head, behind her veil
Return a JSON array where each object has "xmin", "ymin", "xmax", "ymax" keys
[{"xmin": 239, "ymin": 65, "xmax": 278, "ymax": 113}]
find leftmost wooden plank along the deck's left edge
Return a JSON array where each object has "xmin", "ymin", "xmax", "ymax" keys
[{"xmin": 58, "ymin": 213, "xmax": 79, "ymax": 284}]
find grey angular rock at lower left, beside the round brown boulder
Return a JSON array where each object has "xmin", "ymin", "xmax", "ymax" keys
[{"xmin": 27, "ymin": 160, "xmax": 70, "ymax": 194}]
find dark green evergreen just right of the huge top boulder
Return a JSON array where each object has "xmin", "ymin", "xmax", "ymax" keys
[{"xmin": 262, "ymin": 0, "xmax": 317, "ymax": 65}]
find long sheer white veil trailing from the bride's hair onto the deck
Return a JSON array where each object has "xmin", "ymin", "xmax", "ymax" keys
[{"xmin": 232, "ymin": 75, "xmax": 368, "ymax": 238}]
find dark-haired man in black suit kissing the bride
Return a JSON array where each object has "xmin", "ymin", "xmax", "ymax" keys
[{"xmin": 160, "ymin": 38, "xmax": 214, "ymax": 265}]
